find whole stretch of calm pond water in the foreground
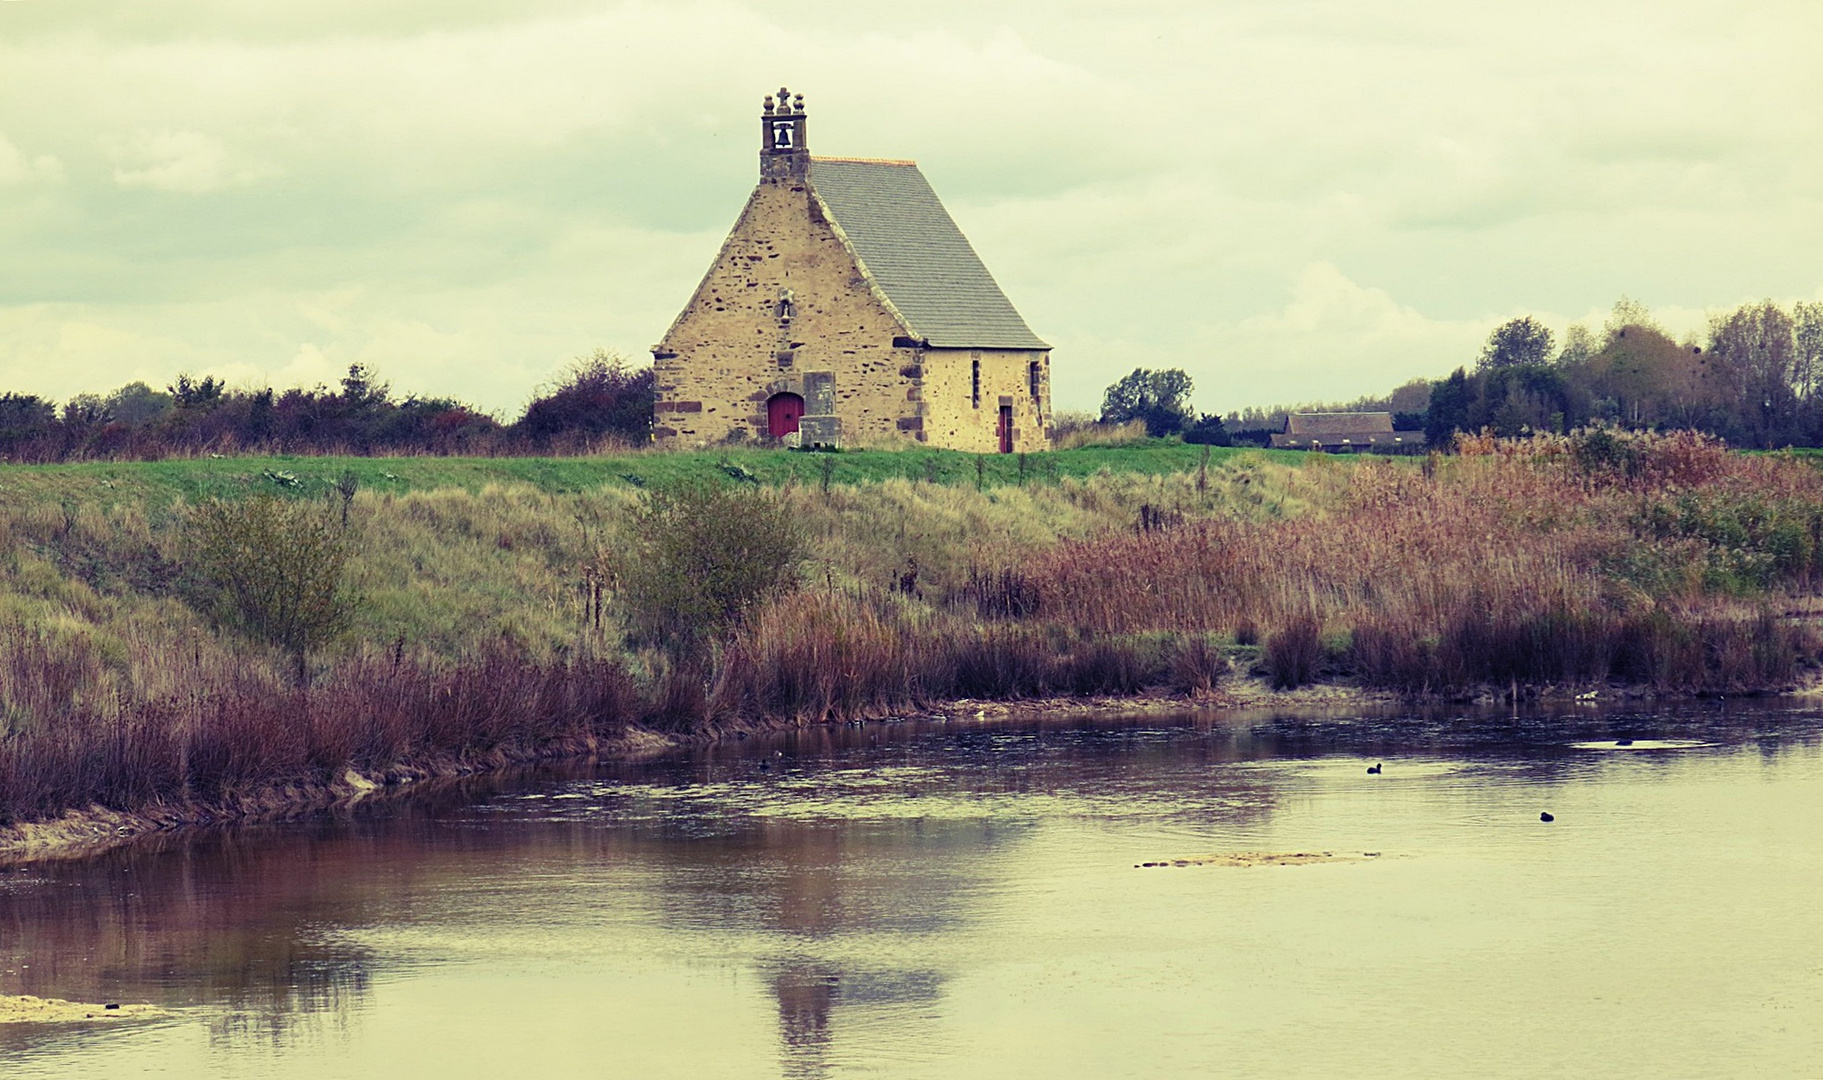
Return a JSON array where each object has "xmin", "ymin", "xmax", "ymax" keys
[{"xmin": 0, "ymin": 702, "xmax": 1823, "ymax": 1080}]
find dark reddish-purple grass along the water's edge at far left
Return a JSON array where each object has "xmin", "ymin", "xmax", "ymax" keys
[{"xmin": 0, "ymin": 646, "xmax": 638, "ymax": 823}]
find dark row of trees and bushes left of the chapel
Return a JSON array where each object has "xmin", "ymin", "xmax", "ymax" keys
[{"xmin": 0, "ymin": 350, "xmax": 653, "ymax": 462}]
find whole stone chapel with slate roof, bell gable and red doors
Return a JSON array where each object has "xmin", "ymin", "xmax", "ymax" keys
[{"xmin": 653, "ymin": 89, "xmax": 1050, "ymax": 452}]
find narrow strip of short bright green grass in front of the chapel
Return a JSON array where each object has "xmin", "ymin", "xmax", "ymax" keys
[{"xmin": 0, "ymin": 440, "xmax": 1309, "ymax": 502}]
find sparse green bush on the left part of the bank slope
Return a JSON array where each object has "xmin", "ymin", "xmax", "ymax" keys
[{"xmin": 190, "ymin": 494, "xmax": 355, "ymax": 682}]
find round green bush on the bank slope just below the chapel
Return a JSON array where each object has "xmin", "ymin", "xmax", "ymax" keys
[{"xmin": 620, "ymin": 482, "xmax": 804, "ymax": 653}]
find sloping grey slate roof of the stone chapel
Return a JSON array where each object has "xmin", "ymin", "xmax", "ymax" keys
[{"xmin": 809, "ymin": 157, "xmax": 1050, "ymax": 348}]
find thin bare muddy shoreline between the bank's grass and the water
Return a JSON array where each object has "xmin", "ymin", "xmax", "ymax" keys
[{"xmin": 0, "ymin": 670, "xmax": 1823, "ymax": 868}]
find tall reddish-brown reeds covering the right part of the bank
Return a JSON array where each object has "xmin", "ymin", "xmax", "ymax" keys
[{"xmin": 1026, "ymin": 436, "xmax": 1823, "ymax": 690}]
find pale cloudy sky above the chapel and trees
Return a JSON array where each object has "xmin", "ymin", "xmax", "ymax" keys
[{"xmin": 0, "ymin": 0, "xmax": 1823, "ymax": 414}]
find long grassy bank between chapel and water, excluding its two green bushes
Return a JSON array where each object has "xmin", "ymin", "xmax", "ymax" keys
[{"xmin": 0, "ymin": 436, "xmax": 1823, "ymax": 839}]
